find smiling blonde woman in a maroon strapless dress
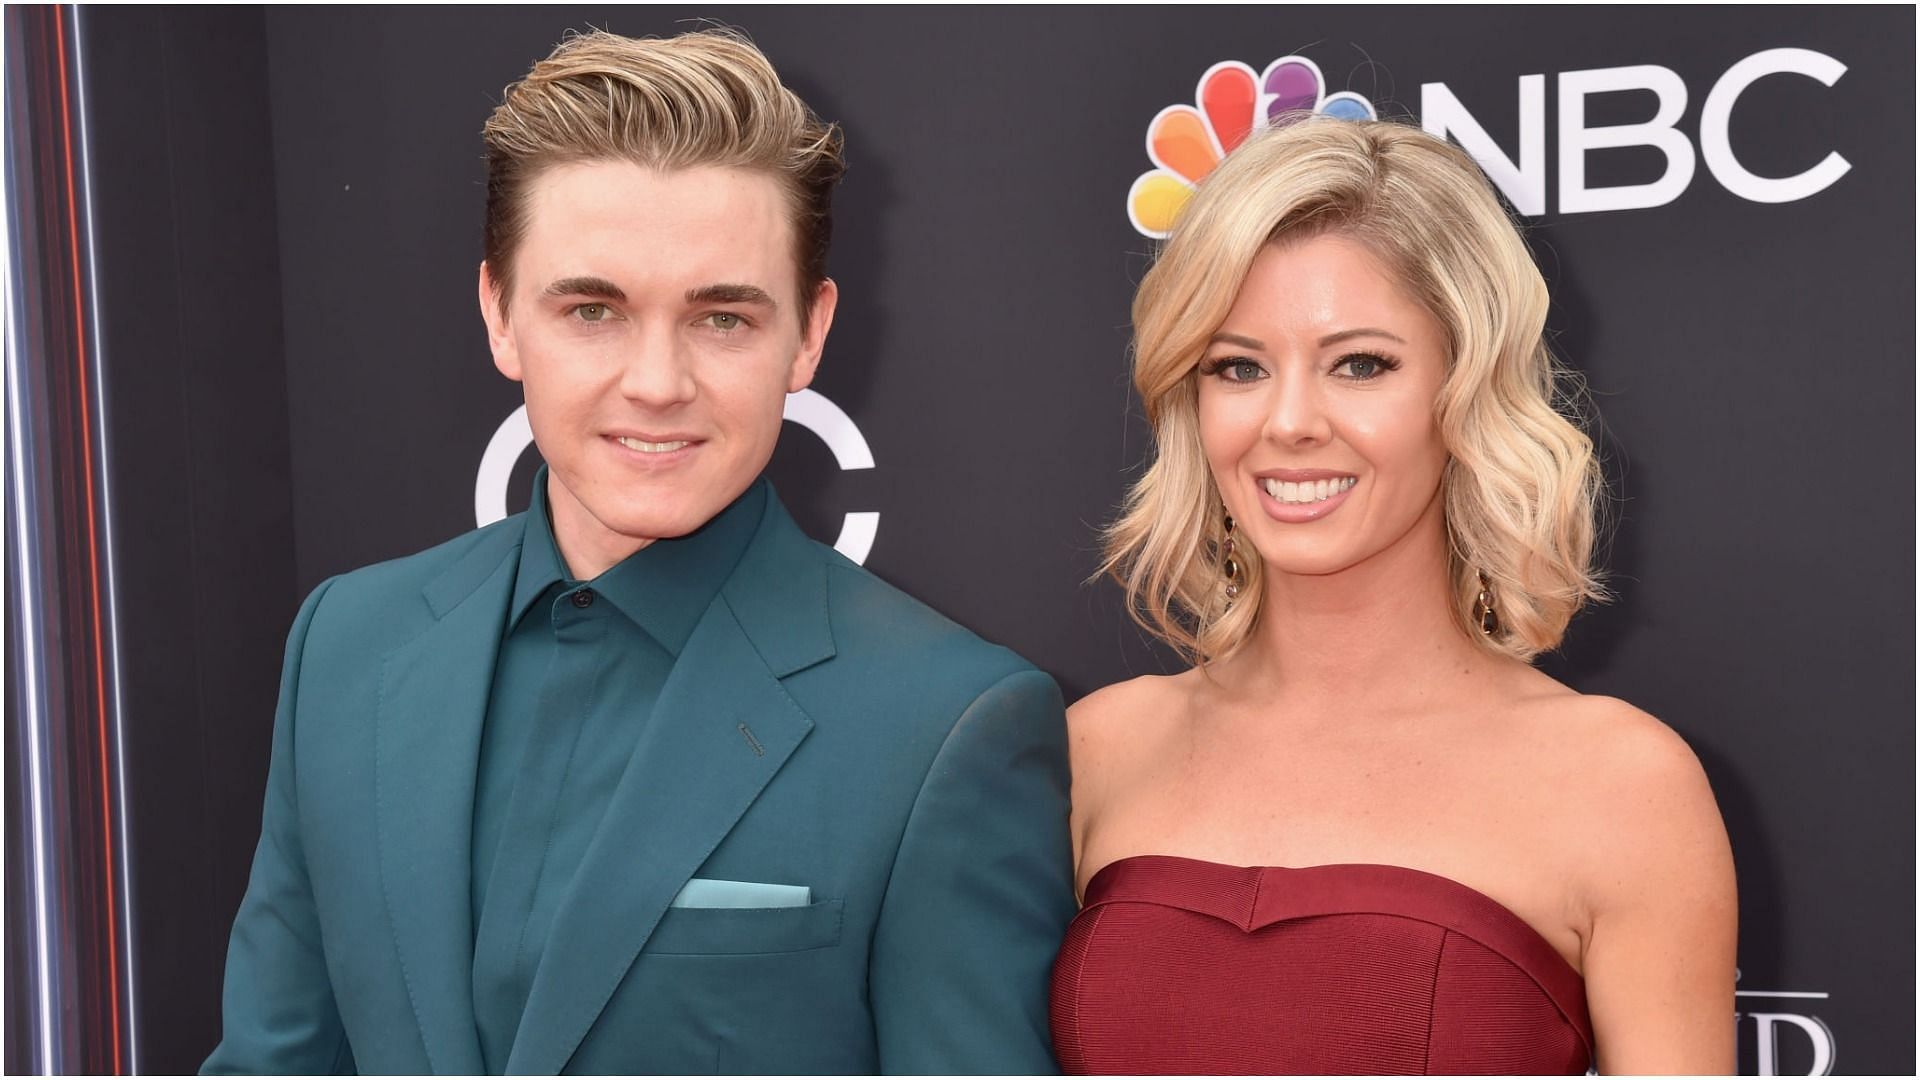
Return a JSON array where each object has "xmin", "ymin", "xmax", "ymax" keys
[{"xmin": 1052, "ymin": 119, "xmax": 1736, "ymax": 1074}]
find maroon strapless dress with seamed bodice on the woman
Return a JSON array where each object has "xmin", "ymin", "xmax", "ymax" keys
[{"xmin": 1052, "ymin": 855, "xmax": 1594, "ymax": 1074}]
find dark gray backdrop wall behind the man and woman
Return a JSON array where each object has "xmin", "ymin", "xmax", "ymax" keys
[{"xmin": 71, "ymin": 8, "xmax": 1914, "ymax": 1072}]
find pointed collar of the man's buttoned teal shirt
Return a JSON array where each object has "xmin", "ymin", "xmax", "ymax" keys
[{"xmin": 522, "ymin": 465, "xmax": 768, "ymax": 657}]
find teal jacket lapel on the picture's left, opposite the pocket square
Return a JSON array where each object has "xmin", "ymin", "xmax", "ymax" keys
[{"xmin": 374, "ymin": 517, "xmax": 524, "ymax": 1074}]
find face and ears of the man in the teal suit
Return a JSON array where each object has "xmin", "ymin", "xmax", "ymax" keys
[{"xmin": 480, "ymin": 161, "xmax": 835, "ymax": 577}]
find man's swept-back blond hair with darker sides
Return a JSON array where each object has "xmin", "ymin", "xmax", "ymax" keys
[{"xmin": 482, "ymin": 31, "xmax": 847, "ymax": 317}]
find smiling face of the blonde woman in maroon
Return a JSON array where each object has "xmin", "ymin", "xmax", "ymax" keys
[{"xmin": 1198, "ymin": 234, "xmax": 1448, "ymax": 575}]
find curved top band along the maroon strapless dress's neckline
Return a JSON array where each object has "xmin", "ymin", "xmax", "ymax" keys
[{"xmin": 1081, "ymin": 855, "xmax": 1594, "ymax": 1049}]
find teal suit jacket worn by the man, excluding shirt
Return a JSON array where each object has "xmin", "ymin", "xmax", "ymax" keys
[{"xmin": 205, "ymin": 486, "xmax": 1075, "ymax": 1072}]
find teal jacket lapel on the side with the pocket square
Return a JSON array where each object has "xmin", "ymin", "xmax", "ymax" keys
[{"xmin": 507, "ymin": 492, "xmax": 833, "ymax": 1074}]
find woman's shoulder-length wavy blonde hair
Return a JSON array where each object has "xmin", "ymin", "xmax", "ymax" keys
[{"xmin": 1100, "ymin": 117, "xmax": 1605, "ymax": 663}]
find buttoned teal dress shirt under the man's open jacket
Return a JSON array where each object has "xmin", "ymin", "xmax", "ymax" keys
[{"xmin": 470, "ymin": 469, "xmax": 766, "ymax": 1072}]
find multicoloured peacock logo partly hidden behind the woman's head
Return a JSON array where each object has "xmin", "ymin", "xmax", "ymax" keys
[{"xmin": 1127, "ymin": 56, "xmax": 1379, "ymax": 240}]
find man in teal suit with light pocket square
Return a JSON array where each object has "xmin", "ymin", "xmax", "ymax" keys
[{"xmin": 205, "ymin": 33, "xmax": 1075, "ymax": 1072}]
